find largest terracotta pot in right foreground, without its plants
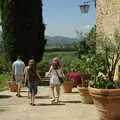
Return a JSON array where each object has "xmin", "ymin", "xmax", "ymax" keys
[{"xmin": 89, "ymin": 87, "xmax": 120, "ymax": 120}]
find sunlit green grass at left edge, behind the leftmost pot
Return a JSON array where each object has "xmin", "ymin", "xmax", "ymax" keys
[{"xmin": 0, "ymin": 73, "xmax": 11, "ymax": 91}]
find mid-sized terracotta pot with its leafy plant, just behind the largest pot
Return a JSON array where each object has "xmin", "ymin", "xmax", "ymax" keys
[{"xmin": 76, "ymin": 54, "xmax": 93, "ymax": 104}]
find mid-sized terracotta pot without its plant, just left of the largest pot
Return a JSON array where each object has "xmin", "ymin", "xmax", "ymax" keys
[{"xmin": 77, "ymin": 86, "xmax": 93, "ymax": 104}]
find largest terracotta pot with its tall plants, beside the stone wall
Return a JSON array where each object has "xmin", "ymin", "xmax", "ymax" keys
[{"xmin": 89, "ymin": 31, "xmax": 120, "ymax": 120}]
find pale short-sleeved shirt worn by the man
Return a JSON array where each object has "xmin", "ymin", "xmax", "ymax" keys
[{"xmin": 12, "ymin": 60, "xmax": 25, "ymax": 75}]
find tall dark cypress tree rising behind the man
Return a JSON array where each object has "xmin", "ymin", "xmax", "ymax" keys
[{"xmin": 0, "ymin": 0, "xmax": 46, "ymax": 62}]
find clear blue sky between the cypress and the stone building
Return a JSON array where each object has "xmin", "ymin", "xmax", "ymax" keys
[{"xmin": 42, "ymin": 0, "xmax": 96, "ymax": 37}]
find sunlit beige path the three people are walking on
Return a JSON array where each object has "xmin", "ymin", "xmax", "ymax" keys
[{"xmin": 0, "ymin": 86, "xmax": 98, "ymax": 120}]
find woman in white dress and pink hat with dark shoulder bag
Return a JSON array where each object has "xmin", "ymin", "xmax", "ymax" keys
[{"xmin": 48, "ymin": 58, "xmax": 63, "ymax": 103}]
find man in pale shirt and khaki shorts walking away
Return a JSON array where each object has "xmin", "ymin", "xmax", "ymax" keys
[{"xmin": 12, "ymin": 56, "xmax": 25, "ymax": 97}]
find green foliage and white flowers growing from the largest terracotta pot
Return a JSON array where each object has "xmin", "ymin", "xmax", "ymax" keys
[{"xmin": 90, "ymin": 31, "xmax": 120, "ymax": 89}]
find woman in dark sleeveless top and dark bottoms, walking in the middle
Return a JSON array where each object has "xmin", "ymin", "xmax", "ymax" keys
[{"xmin": 25, "ymin": 59, "xmax": 40, "ymax": 105}]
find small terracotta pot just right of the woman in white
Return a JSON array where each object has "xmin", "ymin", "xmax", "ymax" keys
[{"xmin": 63, "ymin": 81, "xmax": 73, "ymax": 93}]
